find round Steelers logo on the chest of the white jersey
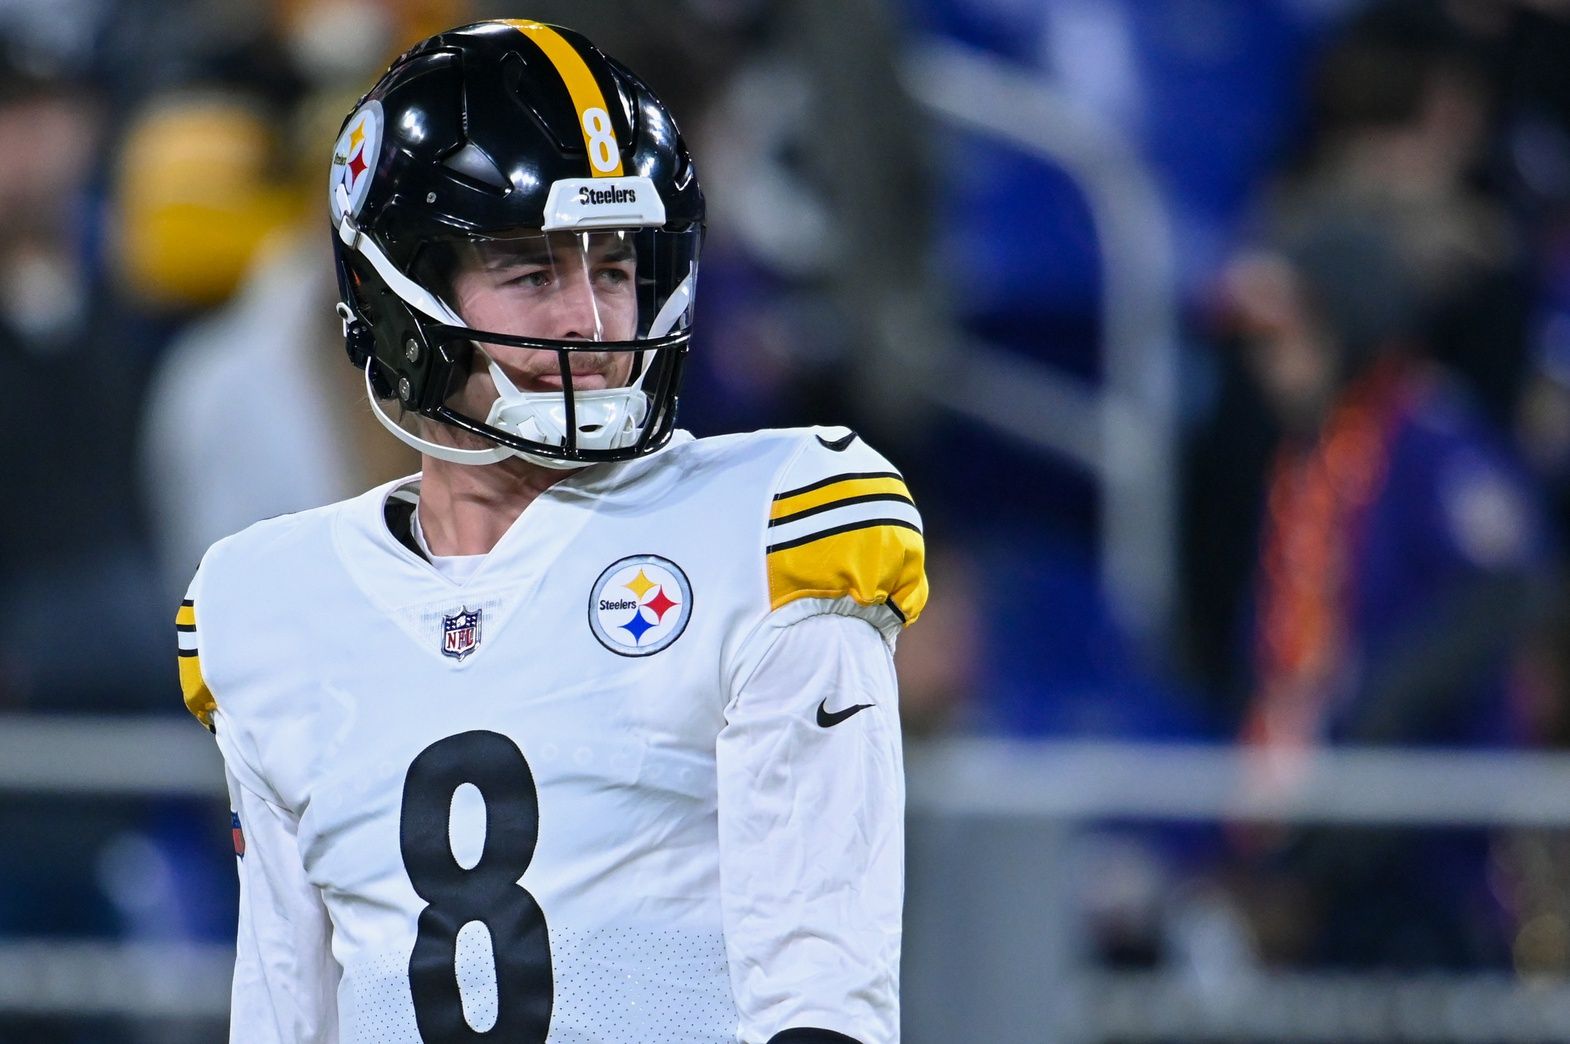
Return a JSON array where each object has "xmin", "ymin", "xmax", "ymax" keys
[{"xmin": 589, "ymin": 554, "xmax": 692, "ymax": 656}]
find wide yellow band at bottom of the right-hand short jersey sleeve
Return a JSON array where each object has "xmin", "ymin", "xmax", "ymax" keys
[{"xmin": 768, "ymin": 518, "xmax": 926, "ymax": 625}]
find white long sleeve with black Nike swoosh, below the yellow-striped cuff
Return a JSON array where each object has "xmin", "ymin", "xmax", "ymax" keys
[{"xmin": 716, "ymin": 614, "xmax": 904, "ymax": 1044}]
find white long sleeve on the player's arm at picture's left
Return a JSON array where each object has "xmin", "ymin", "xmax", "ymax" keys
[{"xmin": 228, "ymin": 762, "xmax": 341, "ymax": 1044}]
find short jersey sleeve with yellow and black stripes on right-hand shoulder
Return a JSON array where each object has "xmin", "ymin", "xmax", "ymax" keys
[{"xmin": 765, "ymin": 429, "xmax": 926, "ymax": 641}]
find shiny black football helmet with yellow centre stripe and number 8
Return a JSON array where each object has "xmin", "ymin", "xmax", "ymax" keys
[{"xmin": 328, "ymin": 20, "xmax": 703, "ymax": 468}]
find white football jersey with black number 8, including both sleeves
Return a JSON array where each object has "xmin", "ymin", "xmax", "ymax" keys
[{"xmin": 177, "ymin": 429, "xmax": 926, "ymax": 1044}]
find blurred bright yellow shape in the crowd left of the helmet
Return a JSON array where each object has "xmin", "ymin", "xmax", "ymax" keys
[{"xmin": 116, "ymin": 96, "xmax": 298, "ymax": 309}]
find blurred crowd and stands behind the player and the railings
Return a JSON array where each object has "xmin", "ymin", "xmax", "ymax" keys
[{"xmin": 15, "ymin": 0, "xmax": 1570, "ymax": 1036}]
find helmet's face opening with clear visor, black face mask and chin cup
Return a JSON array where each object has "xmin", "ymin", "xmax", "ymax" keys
[{"xmin": 389, "ymin": 229, "xmax": 700, "ymax": 466}]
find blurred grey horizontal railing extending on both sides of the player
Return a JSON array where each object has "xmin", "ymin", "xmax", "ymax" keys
[{"xmin": 0, "ymin": 717, "xmax": 1570, "ymax": 1044}]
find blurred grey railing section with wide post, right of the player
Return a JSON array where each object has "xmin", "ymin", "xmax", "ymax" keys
[{"xmin": 904, "ymin": 739, "xmax": 1570, "ymax": 1044}]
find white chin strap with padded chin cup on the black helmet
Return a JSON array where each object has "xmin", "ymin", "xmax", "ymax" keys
[{"xmin": 338, "ymin": 185, "xmax": 697, "ymax": 471}]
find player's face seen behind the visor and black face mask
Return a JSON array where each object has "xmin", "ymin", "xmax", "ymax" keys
[{"xmin": 452, "ymin": 232, "xmax": 637, "ymax": 401}]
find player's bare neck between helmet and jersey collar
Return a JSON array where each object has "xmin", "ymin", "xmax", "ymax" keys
[{"xmin": 419, "ymin": 457, "xmax": 571, "ymax": 556}]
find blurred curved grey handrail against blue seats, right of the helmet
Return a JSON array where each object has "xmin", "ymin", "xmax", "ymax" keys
[{"xmin": 906, "ymin": 41, "xmax": 1178, "ymax": 642}]
